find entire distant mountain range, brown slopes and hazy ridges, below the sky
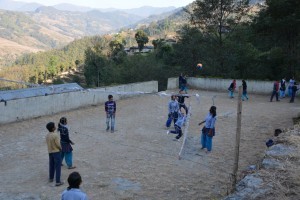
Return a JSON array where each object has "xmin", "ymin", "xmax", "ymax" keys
[{"xmin": 0, "ymin": 0, "xmax": 183, "ymax": 64}]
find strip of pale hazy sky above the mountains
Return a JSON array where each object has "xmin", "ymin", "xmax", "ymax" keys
[{"xmin": 16, "ymin": 0, "xmax": 193, "ymax": 9}]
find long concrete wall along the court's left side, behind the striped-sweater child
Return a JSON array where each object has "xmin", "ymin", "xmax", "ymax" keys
[{"xmin": 0, "ymin": 81, "xmax": 158, "ymax": 124}]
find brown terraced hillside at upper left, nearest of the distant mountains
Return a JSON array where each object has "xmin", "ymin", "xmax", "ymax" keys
[{"xmin": 0, "ymin": 7, "xmax": 142, "ymax": 64}]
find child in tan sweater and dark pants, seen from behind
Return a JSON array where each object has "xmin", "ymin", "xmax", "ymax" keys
[{"xmin": 46, "ymin": 122, "xmax": 63, "ymax": 186}]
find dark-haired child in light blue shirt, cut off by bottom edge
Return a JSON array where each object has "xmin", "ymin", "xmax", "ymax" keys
[{"xmin": 61, "ymin": 172, "xmax": 88, "ymax": 200}]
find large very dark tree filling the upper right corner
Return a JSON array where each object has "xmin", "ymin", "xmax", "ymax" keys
[{"xmin": 252, "ymin": 0, "xmax": 300, "ymax": 79}]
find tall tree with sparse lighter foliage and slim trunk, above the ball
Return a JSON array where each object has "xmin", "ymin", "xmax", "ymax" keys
[{"xmin": 186, "ymin": 0, "xmax": 249, "ymax": 73}]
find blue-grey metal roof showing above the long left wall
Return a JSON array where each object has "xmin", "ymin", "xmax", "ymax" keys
[{"xmin": 0, "ymin": 83, "xmax": 83, "ymax": 101}]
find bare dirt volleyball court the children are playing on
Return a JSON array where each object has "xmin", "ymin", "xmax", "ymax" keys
[{"xmin": 0, "ymin": 90, "xmax": 300, "ymax": 200}]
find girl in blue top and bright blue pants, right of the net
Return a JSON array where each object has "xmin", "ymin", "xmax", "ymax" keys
[{"xmin": 199, "ymin": 106, "xmax": 217, "ymax": 153}]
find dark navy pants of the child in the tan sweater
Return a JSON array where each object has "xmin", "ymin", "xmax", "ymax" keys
[{"xmin": 49, "ymin": 152, "xmax": 61, "ymax": 183}]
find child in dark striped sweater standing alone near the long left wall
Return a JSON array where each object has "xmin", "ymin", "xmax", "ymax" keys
[{"xmin": 105, "ymin": 94, "xmax": 117, "ymax": 133}]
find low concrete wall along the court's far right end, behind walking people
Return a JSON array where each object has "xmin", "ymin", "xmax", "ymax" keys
[{"xmin": 168, "ymin": 77, "xmax": 274, "ymax": 94}]
